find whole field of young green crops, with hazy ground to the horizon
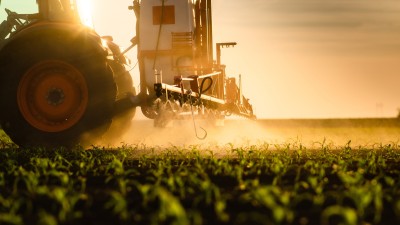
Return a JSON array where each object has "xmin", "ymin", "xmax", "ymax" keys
[{"xmin": 0, "ymin": 119, "xmax": 400, "ymax": 225}]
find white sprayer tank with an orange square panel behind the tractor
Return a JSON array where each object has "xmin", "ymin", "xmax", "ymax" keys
[{"xmin": 138, "ymin": 0, "xmax": 195, "ymax": 90}]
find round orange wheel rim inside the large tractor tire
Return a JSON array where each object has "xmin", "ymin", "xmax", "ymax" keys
[{"xmin": 17, "ymin": 60, "xmax": 89, "ymax": 132}]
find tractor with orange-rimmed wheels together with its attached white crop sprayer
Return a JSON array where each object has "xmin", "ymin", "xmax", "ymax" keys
[{"xmin": 0, "ymin": 0, "xmax": 255, "ymax": 147}]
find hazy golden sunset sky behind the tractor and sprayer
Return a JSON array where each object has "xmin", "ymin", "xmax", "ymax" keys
[{"xmin": 0, "ymin": 0, "xmax": 400, "ymax": 118}]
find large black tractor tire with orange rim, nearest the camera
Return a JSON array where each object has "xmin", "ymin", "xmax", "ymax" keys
[{"xmin": 0, "ymin": 29, "xmax": 116, "ymax": 147}]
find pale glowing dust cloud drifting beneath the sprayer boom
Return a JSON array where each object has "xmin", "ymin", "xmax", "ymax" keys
[{"xmin": 98, "ymin": 119, "xmax": 273, "ymax": 148}]
